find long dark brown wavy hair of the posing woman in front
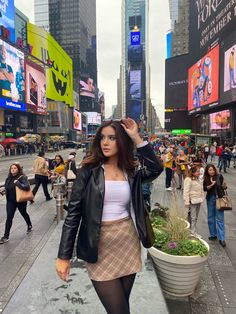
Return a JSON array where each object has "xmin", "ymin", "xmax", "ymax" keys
[{"xmin": 81, "ymin": 121, "xmax": 137, "ymax": 174}]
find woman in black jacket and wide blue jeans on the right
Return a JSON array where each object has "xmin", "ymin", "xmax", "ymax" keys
[{"xmin": 203, "ymin": 164, "xmax": 226, "ymax": 247}]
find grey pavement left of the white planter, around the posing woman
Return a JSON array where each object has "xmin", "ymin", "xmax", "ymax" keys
[{"xmin": 0, "ymin": 190, "xmax": 168, "ymax": 314}]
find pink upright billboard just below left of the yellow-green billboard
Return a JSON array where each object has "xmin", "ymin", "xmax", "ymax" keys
[{"xmin": 25, "ymin": 61, "xmax": 47, "ymax": 114}]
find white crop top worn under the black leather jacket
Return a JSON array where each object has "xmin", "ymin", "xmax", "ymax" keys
[{"xmin": 102, "ymin": 181, "xmax": 131, "ymax": 221}]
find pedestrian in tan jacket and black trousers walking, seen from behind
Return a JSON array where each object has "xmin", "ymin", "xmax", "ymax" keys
[{"xmin": 31, "ymin": 152, "xmax": 52, "ymax": 203}]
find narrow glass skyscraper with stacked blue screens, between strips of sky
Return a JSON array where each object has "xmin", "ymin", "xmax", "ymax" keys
[{"xmin": 121, "ymin": 0, "xmax": 150, "ymax": 127}]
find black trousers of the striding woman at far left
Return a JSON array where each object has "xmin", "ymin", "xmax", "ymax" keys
[{"xmin": 4, "ymin": 201, "xmax": 32, "ymax": 238}]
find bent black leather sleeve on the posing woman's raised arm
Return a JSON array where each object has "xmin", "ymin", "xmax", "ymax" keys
[{"xmin": 137, "ymin": 144, "xmax": 163, "ymax": 182}]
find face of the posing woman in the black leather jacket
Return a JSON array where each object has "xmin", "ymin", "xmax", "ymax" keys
[{"xmin": 100, "ymin": 126, "xmax": 118, "ymax": 158}]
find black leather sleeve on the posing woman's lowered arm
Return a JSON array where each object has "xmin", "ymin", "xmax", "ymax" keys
[{"xmin": 58, "ymin": 168, "xmax": 88, "ymax": 260}]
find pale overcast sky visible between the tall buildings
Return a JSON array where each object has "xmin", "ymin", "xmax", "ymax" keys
[{"xmin": 15, "ymin": 0, "xmax": 170, "ymax": 124}]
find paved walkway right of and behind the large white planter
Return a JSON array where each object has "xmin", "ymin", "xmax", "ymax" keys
[{"xmin": 152, "ymin": 168, "xmax": 236, "ymax": 314}]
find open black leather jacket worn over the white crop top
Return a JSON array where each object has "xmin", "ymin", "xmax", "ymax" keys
[{"xmin": 58, "ymin": 144, "xmax": 163, "ymax": 263}]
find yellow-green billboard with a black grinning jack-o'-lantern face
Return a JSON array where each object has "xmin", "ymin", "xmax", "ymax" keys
[{"xmin": 27, "ymin": 23, "xmax": 73, "ymax": 107}]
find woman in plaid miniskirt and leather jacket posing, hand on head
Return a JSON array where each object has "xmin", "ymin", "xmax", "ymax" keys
[{"xmin": 56, "ymin": 118, "xmax": 163, "ymax": 314}]
